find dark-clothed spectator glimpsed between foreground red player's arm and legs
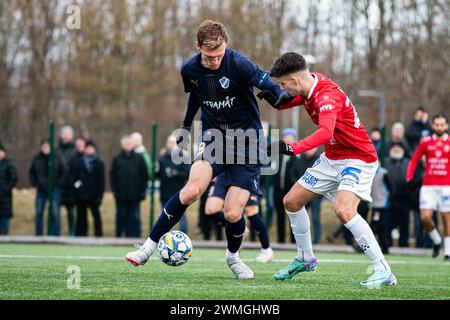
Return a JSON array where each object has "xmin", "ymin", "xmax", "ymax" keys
[{"xmin": 292, "ymin": 148, "xmax": 323, "ymax": 244}]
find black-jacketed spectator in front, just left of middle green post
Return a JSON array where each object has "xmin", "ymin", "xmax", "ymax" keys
[{"xmin": 110, "ymin": 136, "xmax": 149, "ymax": 238}]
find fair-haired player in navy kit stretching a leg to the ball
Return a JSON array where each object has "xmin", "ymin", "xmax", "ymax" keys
[{"xmin": 125, "ymin": 20, "xmax": 286, "ymax": 279}]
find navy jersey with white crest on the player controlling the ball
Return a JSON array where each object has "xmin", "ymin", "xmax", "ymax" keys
[{"xmin": 181, "ymin": 49, "xmax": 281, "ymax": 132}]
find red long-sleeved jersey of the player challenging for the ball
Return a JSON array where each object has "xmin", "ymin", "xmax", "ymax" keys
[{"xmin": 280, "ymin": 72, "xmax": 378, "ymax": 163}]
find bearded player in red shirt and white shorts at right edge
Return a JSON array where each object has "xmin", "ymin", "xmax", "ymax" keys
[{"xmin": 406, "ymin": 115, "xmax": 450, "ymax": 262}]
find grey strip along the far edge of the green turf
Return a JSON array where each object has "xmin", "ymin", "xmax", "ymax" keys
[{"xmin": 0, "ymin": 236, "xmax": 431, "ymax": 256}]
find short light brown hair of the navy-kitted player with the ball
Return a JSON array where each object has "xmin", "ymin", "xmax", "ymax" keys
[{"xmin": 197, "ymin": 19, "xmax": 228, "ymax": 50}]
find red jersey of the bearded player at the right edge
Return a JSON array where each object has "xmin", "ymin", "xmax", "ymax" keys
[{"xmin": 406, "ymin": 134, "xmax": 450, "ymax": 186}]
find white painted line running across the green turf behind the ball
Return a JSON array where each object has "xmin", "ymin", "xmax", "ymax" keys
[{"xmin": 0, "ymin": 254, "xmax": 444, "ymax": 266}]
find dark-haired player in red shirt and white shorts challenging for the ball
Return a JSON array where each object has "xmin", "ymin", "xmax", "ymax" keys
[{"xmin": 262, "ymin": 52, "xmax": 397, "ymax": 287}]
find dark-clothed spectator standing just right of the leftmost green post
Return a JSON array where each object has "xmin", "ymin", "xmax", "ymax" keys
[{"xmin": 58, "ymin": 126, "xmax": 77, "ymax": 236}]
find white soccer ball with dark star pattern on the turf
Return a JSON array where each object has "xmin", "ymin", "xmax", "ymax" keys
[{"xmin": 158, "ymin": 231, "xmax": 192, "ymax": 267}]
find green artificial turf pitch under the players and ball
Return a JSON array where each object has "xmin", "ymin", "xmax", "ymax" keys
[{"xmin": 0, "ymin": 244, "xmax": 450, "ymax": 300}]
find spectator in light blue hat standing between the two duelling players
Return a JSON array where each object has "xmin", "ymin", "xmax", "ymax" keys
[{"xmin": 273, "ymin": 128, "xmax": 301, "ymax": 243}]
